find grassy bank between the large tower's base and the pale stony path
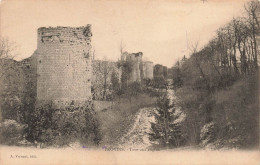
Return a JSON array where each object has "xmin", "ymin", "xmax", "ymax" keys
[{"xmin": 97, "ymin": 94, "xmax": 156, "ymax": 146}]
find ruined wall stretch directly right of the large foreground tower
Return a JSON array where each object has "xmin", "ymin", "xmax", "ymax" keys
[{"xmin": 91, "ymin": 60, "xmax": 121, "ymax": 100}]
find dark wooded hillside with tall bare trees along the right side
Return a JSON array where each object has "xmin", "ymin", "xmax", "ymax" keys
[{"xmin": 173, "ymin": 1, "xmax": 260, "ymax": 147}]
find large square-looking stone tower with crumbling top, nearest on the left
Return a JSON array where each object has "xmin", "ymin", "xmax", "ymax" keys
[{"xmin": 37, "ymin": 25, "xmax": 92, "ymax": 105}]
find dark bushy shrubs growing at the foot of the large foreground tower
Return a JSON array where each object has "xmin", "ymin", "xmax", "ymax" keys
[{"xmin": 27, "ymin": 103, "xmax": 101, "ymax": 146}]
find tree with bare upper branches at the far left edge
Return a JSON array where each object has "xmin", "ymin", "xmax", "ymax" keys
[{"xmin": 0, "ymin": 38, "xmax": 24, "ymax": 121}]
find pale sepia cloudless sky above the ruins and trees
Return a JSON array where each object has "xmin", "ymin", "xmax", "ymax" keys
[{"xmin": 0, "ymin": 0, "xmax": 250, "ymax": 67}]
